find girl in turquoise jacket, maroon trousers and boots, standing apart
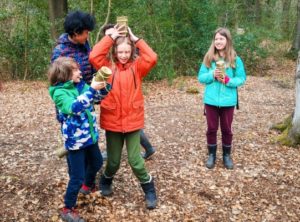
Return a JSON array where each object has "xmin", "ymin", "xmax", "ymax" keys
[{"xmin": 198, "ymin": 28, "xmax": 246, "ymax": 169}]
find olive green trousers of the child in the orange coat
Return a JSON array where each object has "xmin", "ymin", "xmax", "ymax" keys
[{"xmin": 104, "ymin": 130, "xmax": 150, "ymax": 183}]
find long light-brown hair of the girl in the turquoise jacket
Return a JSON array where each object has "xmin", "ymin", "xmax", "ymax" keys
[{"xmin": 203, "ymin": 28, "xmax": 236, "ymax": 68}]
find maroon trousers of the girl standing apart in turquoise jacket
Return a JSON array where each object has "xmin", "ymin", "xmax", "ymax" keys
[{"xmin": 205, "ymin": 104, "xmax": 234, "ymax": 146}]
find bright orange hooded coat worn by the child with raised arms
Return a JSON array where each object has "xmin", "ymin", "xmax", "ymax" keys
[{"xmin": 89, "ymin": 36, "xmax": 157, "ymax": 133}]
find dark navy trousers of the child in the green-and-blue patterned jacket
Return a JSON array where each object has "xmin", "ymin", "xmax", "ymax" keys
[{"xmin": 65, "ymin": 143, "xmax": 103, "ymax": 208}]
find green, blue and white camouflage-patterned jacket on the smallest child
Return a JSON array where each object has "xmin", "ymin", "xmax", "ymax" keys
[{"xmin": 49, "ymin": 81, "xmax": 107, "ymax": 150}]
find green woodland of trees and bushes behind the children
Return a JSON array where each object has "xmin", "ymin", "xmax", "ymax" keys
[{"xmin": 0, "ymin": 0, "xmax": 300, "ymax": 80}]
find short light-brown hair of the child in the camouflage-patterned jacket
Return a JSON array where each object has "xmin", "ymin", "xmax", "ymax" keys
[{"xmin": 48, "ymin": 57, "xmax": 79, "ymax": 86}]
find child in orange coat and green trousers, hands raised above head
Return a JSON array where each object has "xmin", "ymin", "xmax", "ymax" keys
[{"xmin": 89, "ymin": 26, "xmax": 157, "ymax": 209}]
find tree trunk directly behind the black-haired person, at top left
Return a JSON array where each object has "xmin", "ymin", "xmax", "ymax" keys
[{"xmin": 48, "ymin": 0, "xmax": 68, "ymax": 39}]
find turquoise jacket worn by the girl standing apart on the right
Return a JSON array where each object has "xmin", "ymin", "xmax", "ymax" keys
[{"xmin": 198, "ymin": 56, "xmax": 246, "ymax": 107}]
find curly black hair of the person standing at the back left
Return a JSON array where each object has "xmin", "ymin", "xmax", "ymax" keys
[{"xmin": 64, "ymin": 11, "xmax": 96, "ymax": 36}]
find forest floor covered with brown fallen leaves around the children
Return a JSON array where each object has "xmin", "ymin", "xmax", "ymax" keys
[{"xmin": 0, "ymin": 58, "xmax": 300, "ymax": 222}]
